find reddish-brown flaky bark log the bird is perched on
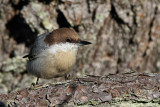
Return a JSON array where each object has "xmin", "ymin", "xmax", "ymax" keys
[{"xmin": 0, "ymin": 72, "xmax": 160, "ymax": 107}]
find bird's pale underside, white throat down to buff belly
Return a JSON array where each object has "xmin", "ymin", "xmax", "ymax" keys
[{"xmin": 27, "ymin": 43, "xmax": 78, "ymax": 78}]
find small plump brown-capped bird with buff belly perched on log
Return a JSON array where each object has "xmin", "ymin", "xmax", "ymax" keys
[{"xmin": 23, "ymin": 28, "xmax": 91, "ymax": 85}]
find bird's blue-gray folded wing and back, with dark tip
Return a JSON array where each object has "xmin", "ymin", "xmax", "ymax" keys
[{"xmin": 23, "ymin": 32, "xmax": 49, "ymax": 60}]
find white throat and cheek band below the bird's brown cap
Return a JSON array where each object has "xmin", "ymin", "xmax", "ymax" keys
[{"xmin": 47, "ymin": 42, "xmax": 79, "ymax": 54}]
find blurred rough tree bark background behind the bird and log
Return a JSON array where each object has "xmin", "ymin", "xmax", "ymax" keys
[{"xmin": 0, "ymin": 0, "xmax": 160, "ymax": 94}]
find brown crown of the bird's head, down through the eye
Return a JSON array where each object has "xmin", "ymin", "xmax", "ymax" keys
[{"xmin": 44, "ymin": 28, "xmax": 80, "ymax": 45}]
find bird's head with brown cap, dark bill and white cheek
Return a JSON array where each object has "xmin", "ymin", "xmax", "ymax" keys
[{"xmin": 44, "ymin": 28, "xmax": 91, "ymax": 53}]
